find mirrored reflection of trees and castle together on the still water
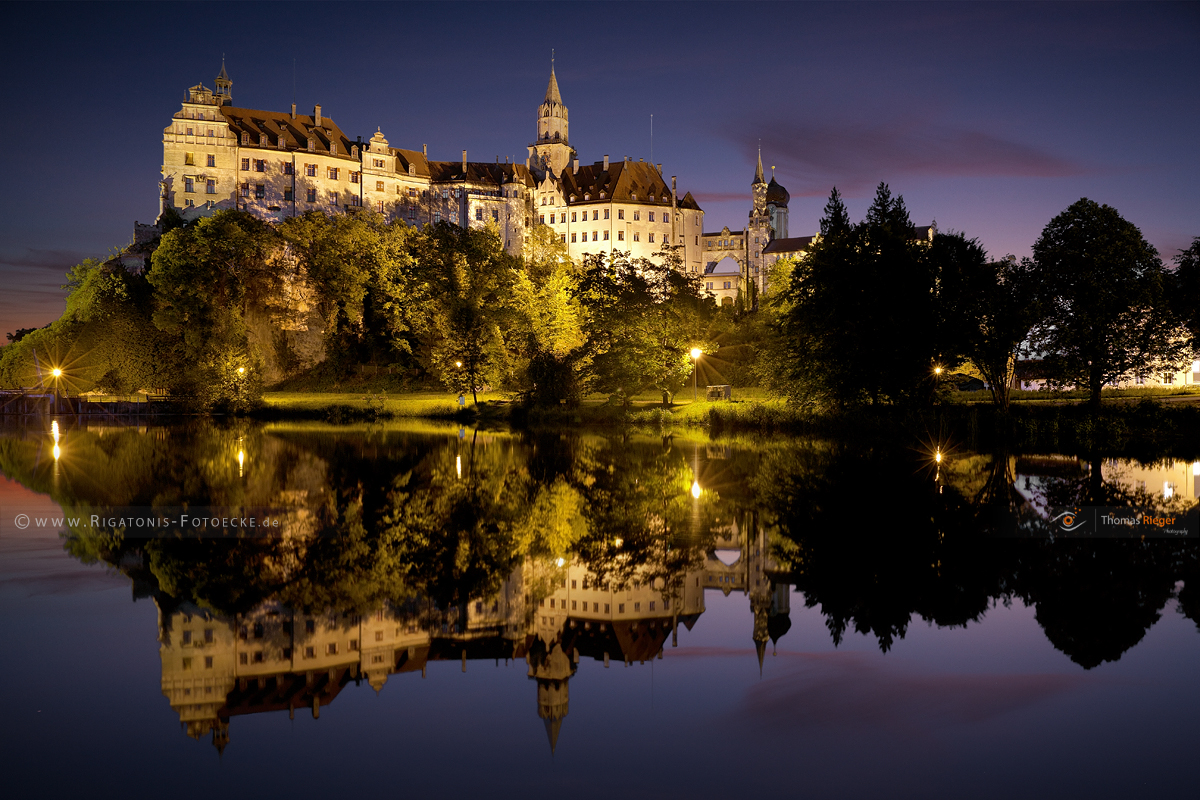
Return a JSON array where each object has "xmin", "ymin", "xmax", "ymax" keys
[{"xmin": 0, "ymin": 422, "xmax": 1198, "ymax": 748}]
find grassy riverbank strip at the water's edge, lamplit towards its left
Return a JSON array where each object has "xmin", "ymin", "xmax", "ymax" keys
[{"xmin": 254, "ymin": 390, "xmax": 1200, "ymax": 458}]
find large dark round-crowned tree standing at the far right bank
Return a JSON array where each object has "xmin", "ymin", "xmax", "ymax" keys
[{"xmin": 1032, "ymin": 198, "xmax": 1186, "ymax": 410}]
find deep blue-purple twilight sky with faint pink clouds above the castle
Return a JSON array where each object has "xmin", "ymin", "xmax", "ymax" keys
[{"xmin": 0, "ymin": 2, "xmax": 1200, "ymax": 342}]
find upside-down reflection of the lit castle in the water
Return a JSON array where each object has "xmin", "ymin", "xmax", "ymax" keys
[{"xmin": 158, "ymin": 515, "xmax": 791, "ymax": 751}]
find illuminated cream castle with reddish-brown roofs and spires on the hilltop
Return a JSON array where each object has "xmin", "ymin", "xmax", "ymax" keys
[{"xmin": 160, "ymin": 56, "xmax": 808, "ymax": 303}]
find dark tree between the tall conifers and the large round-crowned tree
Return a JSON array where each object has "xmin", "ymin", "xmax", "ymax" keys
[{"xmin": 929, "ymin": 233, "xmax": 1038, "ymax": 414}]
